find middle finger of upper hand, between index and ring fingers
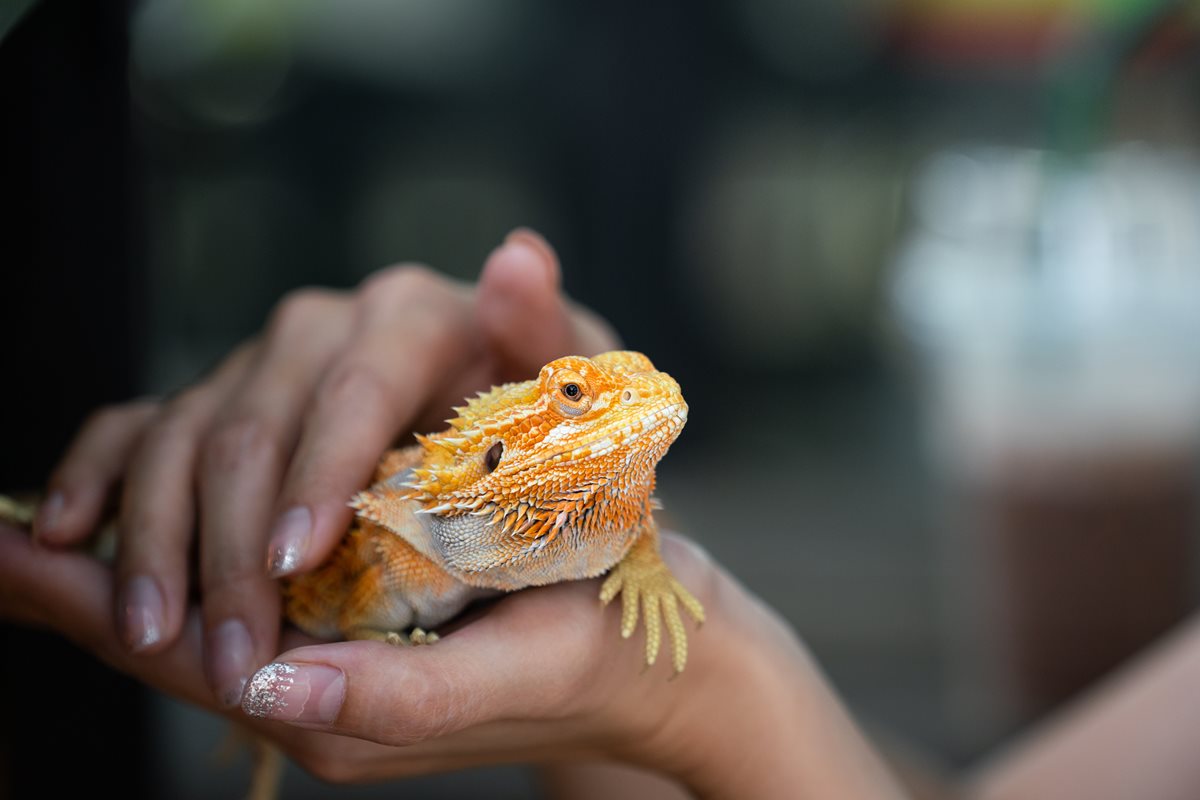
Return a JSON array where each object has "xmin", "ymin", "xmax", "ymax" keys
[{"xmin": 198, "ymin": 290, "xmax": 352, "ymax": 708}]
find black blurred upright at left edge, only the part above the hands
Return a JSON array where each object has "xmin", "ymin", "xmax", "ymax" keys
[{"xmin": 0, "ymin": 0, "xmax": 143, "ymax": 487}]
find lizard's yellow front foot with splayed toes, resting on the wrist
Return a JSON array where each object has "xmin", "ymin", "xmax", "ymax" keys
[{"xmin": 600, "ymin": 521, "xmax": 704, "ymax": 674}]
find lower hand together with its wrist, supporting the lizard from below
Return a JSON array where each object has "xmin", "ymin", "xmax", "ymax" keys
[{"xmin": 0, "ymin": 515, "xmax": 898, "ymax": 798}]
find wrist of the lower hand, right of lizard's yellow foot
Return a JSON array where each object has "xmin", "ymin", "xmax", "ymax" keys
[{"xmin": 642, "ymin": 567, "xmax": 900, "ymax": 799}]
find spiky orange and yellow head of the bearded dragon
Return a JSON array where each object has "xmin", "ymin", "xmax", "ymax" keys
[{"xmin": 407, "ymin": 351, "xmax": 688, "ymax": 541}]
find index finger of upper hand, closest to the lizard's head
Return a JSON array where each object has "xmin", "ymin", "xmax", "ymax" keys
[{"xmin": 269, "ymin": 267, "xmax": 476, "ymax": 577}]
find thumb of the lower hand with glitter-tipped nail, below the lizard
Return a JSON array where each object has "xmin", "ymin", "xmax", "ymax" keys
[{"xmin": 242, "ymin": 584, "xmax": 614, "ymax": 752}]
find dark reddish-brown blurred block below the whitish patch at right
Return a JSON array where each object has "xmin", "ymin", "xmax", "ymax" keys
[{"xmin": 976, "ymin": 451, "xmax": 1198, "ymax": 718}]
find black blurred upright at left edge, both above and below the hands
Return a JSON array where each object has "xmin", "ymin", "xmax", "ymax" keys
[{"xmin": 0, "ymin": 0, "xmax": 149, "ymax": 798}]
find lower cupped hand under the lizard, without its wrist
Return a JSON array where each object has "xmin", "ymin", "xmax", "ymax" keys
[{"xmin": 0, "ymin": 513, "xmax": 724, "ymax": 782}]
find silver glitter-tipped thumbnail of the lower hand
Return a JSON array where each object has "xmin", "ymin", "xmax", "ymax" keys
[{"xmin": 241, "ymin": 662, "xmax": 346, "ymax": 724}]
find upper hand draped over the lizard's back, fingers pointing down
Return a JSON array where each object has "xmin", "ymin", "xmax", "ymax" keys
[{"xmin": 35, "ymin": 230, "xmax": 614, "ymax": 706}]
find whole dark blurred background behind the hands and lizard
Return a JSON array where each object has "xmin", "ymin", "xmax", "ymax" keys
[{"xmin": 0, "ymin": 0, "xmax": 1200, "ymax": 798}]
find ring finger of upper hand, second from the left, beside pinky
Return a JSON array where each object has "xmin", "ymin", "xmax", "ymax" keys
[{"xmin": 115, "ymin": 344, "xmax": 257, "ymax": 652}]
